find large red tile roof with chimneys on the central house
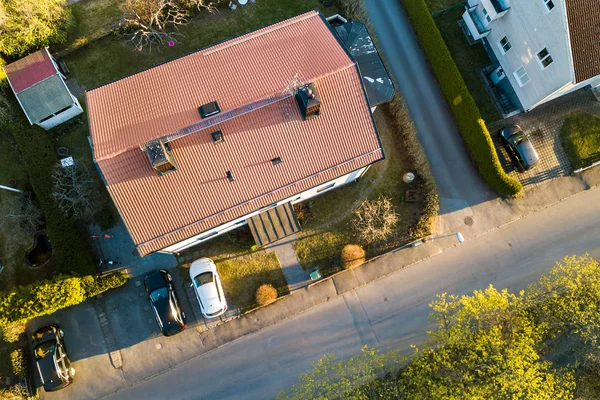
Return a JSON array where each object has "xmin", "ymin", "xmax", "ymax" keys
[{"xmin": 87, "ymin": 11, "xmax": 383, "ymax": 255}]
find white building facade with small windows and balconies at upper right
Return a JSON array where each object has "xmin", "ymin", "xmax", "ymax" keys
[{"xmin": 462, "ymin": 0, "xmax": 600, "ymax": 116}]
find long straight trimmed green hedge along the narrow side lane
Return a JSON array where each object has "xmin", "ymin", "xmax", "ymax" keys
[{"xmin": 402, "ymin": 0, "xmax": 523, "ymax": 196}]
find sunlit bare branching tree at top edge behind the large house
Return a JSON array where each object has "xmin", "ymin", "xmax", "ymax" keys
[{"xmin": 121, "ymin": 0, "xmax": 217, "ymax": 51}]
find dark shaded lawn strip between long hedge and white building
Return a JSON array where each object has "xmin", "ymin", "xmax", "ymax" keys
[{"xmin": 435, "ymin": 7, "xmax": 500, "ymax": 122}]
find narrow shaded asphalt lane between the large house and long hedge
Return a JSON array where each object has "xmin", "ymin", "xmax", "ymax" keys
[{"xmin": 365, "ymin": 0, "xmax": 495, "ymax": 209}]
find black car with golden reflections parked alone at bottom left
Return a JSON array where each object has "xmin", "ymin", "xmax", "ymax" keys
[{"xmin": 31, "ymin": 325, "xmax": 75, "ymax": 392}]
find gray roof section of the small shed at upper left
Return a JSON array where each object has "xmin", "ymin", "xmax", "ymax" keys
[{"xmin": 17, "ymin": 74, "xmax": 73, "ymax": 124}]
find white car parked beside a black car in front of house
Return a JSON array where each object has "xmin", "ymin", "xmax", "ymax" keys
[{"xmin": 190, "ymin": 258, "xmax": 227, "ymax": 318}]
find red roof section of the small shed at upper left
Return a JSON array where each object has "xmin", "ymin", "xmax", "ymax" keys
[{"xmin": 3, "ymin": 48, "xmax": 56, "ymax": 93}]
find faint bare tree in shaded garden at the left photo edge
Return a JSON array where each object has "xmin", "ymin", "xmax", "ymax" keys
[{"xmin": 0, "ymin": 193, "xmax": 42, "ymax": 242}]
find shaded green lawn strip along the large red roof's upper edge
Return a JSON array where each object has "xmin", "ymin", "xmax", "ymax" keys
[{"xmin": 65, "ymin": 0, "xmax": 336, "ymax": 89}]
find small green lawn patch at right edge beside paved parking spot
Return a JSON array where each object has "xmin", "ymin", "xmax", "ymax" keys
[{"xmin": 560, "ymin": 113, "xmax": 600, "ymax": 169}]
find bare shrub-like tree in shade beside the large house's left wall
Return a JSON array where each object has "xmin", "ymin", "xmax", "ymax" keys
[{"xmin": 52, "ymin": 159, "xmax": 95, "ymax": 219}]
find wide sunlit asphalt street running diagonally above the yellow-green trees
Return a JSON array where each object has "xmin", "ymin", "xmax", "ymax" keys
[{"xmin": 103, "ymin": 188, "xmax": 600, "ymax": 400}]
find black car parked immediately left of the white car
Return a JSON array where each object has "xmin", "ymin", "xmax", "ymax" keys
[{"xmin": 144, "ymin": 269, "xmax": 185, "ymax": 336}]
